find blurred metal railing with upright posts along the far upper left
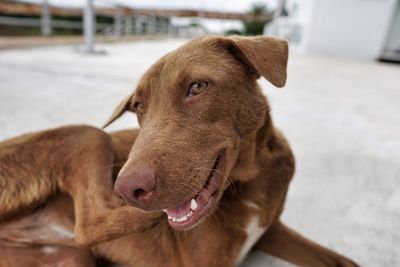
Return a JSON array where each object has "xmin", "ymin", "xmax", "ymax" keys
[{"xmin": 0, "ymin": 0, "xmax": 273, "ymax": 53}]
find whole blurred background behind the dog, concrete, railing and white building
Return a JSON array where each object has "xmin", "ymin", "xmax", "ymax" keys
[{"xmin": 0, "ymin": 0, "xmax": 400, "ymax": 267}]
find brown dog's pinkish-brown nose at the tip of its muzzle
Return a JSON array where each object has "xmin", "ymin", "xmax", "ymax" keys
[{"xmin": 114, "ymin": 167, "xmax": 156, "ymax": 210}]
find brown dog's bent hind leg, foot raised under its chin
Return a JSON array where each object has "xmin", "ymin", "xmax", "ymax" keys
[{"xmin": 0, "ymin": 126, "xmax": 161, "ymax": 249}]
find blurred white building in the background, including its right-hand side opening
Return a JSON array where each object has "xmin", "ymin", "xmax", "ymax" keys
[{"xmin": 265, "ymin": 0, "xmax": 400, "ymax": 59}]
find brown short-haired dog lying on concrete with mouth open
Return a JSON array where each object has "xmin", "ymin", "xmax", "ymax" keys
[{"xmin": 0, "ymin": 37, "xmax": 355, "ymax": 267}]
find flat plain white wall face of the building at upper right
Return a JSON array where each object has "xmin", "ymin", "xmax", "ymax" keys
[{"xmin": 300, "ymin": 0, "xmax": 397, "ymax": 59}]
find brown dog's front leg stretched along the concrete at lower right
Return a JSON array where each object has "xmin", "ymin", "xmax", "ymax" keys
[{"xmin": 255, "ymin": 222, "xmax": 358, "ymax": 267}]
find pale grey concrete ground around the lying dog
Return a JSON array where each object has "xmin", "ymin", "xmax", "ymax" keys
[{"xmin": 0, "ymin": 40, "xmax": 400, "ymax": 267}]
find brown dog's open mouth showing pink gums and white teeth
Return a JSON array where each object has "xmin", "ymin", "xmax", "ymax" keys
[{"xmin": 163, "ymin": 152, "xmax": 224, "ymax": 230}]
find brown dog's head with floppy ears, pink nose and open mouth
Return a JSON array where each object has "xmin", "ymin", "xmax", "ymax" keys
[{"xmin": 106, "ymin": 36, "xmax": 288, "ymax": 230}]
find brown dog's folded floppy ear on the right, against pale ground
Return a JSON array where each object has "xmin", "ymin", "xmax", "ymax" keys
[{"xmin": 228, "ymin": 36, "xmax": 289, "ymax": 87}]
